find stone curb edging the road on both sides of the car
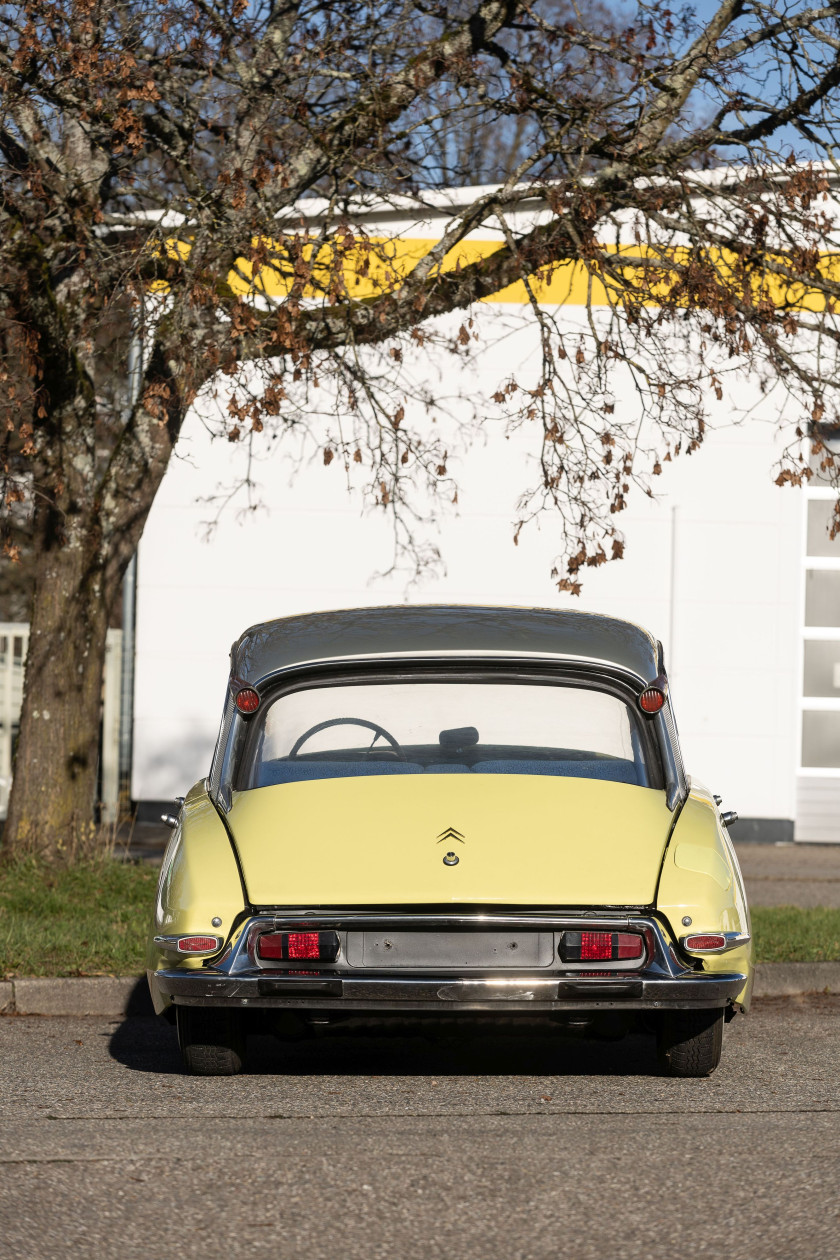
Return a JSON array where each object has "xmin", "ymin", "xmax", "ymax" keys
[{"xmin": 0, "ymin": 963, "xmax": 840, "ymax": 1019}]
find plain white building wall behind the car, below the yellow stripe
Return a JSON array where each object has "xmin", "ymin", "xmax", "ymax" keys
[{"xmin": 132, "ymin": 307, "xmax": 803, "ymax": 819}]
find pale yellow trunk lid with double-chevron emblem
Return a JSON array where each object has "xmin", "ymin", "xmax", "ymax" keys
[{"xmin": 229, "ymin": 774, "xmax": 671, "ymax": 907}]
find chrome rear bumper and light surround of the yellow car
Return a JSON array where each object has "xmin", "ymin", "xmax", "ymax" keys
[{"xmin": 149, "ymin": 912, "xmax": 748, "ymax": 1013}]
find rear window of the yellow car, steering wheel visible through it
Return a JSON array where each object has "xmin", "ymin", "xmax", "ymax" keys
[{"xmin": 241, "ymin": 679, "xmax": 655, "ymax": 788}]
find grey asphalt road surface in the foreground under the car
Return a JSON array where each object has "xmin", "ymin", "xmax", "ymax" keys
[{"xmin": 0, "ymin": 997, "xmax": 840, "ymax": 1260}]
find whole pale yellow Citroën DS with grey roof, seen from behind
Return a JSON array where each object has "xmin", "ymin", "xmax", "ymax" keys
[{"xmin": 147, "ymin": 606, "xmax": 753, "ymax": 1076}]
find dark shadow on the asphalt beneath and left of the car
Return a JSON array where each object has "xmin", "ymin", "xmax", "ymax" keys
[{"xmin": 110, "ymin": 1016, "xmax": 657, "ymax": 1077}]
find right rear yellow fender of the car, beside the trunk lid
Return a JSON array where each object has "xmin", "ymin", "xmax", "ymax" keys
[{"xmin": 656, "ymin": 784, "xmax": 753, "ymax": 1008}]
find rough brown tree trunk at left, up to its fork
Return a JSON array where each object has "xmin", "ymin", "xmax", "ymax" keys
[{"xmin": 0, "ymin": 327, "xmax": 194, "ymax": 862}]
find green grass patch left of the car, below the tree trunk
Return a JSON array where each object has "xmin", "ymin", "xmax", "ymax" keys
[{"xmin": 0, "ymin": 858, "xmax": 157, "ymax": 977}]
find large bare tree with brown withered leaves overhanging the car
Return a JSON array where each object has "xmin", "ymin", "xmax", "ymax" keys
[{"xmin": 0, "ymin": 0, "xmax": 840, "ymax": 856}]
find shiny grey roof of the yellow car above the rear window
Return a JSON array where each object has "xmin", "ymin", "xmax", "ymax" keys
[{"xmin": 230, "ymin": 604, "xmax": 661, "ymax": 684}]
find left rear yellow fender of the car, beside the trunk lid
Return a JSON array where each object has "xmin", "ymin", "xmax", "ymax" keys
[{"xmin": 146, "ymin": 782, "xmax": 244, "ymax": 1004}]
